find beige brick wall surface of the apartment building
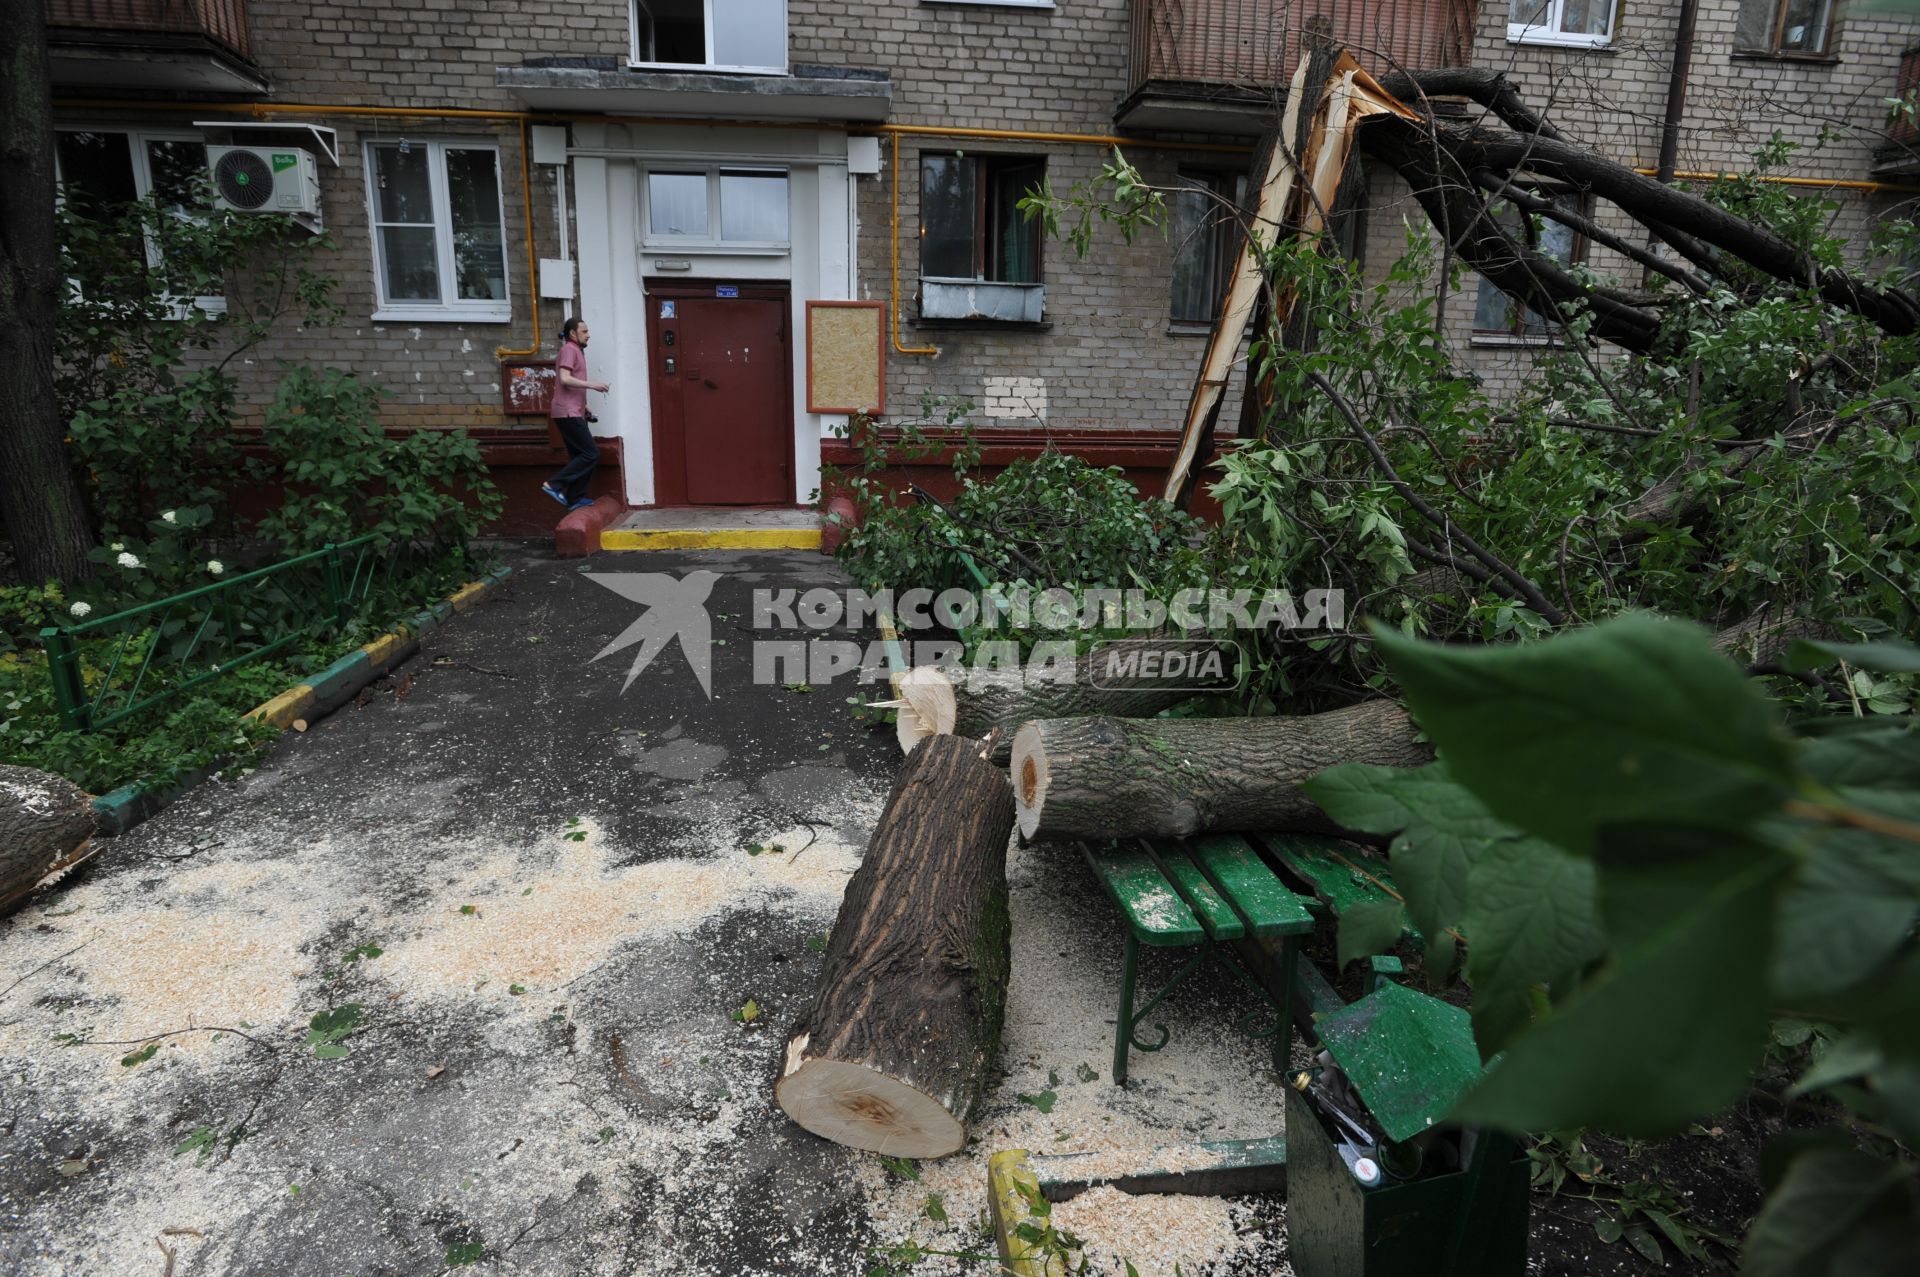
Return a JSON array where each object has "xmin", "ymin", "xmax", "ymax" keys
[{"xmin": 52, "ymin": 0, "xmax": 1920, "ymax": 428}]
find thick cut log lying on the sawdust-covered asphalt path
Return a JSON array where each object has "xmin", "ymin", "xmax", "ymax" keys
[{"xmin": 774, "ymin": 735, "xmax": 1014, "ymax": 1158}]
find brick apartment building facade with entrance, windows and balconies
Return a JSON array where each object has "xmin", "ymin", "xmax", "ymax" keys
[{"xmin": 52, "ymin": 0, "xmax": 1920, "ymax": 518}]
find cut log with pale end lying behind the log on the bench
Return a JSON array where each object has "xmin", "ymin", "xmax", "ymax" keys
[{"xmin": 895, "ymin": 638, "xmax": 1238, "ymax": 762}]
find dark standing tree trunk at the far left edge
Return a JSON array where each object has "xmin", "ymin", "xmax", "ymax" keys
[{"xmin": 0, "ymin": 0, "xmax": 92, "ymax": 582}]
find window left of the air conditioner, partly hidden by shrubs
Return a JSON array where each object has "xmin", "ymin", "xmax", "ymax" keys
[{"xmin": 54, "ymin": 129, "xmax": 227, "ymax": 313}]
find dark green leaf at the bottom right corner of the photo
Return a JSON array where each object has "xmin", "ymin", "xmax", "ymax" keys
[{"xmin": 1740, "ymin": 1148, "xmax": 1920, "ymax": 1277}]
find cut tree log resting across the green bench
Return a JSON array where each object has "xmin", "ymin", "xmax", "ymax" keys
[{"xmin": 1012, "ymin": 701, "xmax": 1434, "ymax": 839}]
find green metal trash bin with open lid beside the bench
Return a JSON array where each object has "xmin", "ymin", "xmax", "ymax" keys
[{"xmin": 1286, "ymin": 983, "xmax": 1528, "ymax": 1277}]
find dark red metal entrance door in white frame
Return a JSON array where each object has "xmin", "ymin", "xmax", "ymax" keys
[{"xmin": 647, "ymin": 284, "xmax": 793, "ymax": 505}]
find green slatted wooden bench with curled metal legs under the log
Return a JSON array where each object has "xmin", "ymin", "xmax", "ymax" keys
[{"xmin": 1081, "ymin": 833, "xmax": 1313, "ymax": 1085}]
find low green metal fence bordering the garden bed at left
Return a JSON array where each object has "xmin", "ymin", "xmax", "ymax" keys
[{"xmin": 40, "ymin": 534, "xmax": 397, "ymax": 732}]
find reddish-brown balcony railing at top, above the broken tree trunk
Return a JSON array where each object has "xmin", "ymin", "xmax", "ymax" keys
[{"xmin": 1131, "ymin": 0, "xmax": 1473, "ymax": 92}]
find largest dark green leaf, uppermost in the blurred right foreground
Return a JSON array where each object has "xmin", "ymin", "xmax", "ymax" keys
[{"xmin": 1377, "ymin": 616, "xmax": 1793, "ymax": 853}]
